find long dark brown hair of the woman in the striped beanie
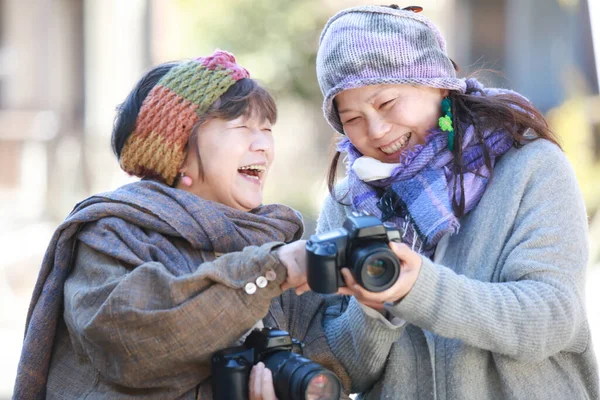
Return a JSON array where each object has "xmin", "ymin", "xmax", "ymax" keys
[{"xmin": 327, "ymin": 76, "xmax": 560, "ymax": 218}]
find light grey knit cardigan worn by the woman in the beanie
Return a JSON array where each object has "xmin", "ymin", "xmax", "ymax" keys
[{"xmin": 317, "ymin": 140, "xmax": 599, "ymax": 400}]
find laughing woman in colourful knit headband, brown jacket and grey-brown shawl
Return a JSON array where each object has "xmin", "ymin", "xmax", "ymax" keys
[{"xmin": 14, "ymin": 51, "xmax": 348, "ymax": 399}]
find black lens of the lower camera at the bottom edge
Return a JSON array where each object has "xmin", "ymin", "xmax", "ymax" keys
[{"xmin": 263, "ymin": 351, "xmax": 342, "ymax": 400}]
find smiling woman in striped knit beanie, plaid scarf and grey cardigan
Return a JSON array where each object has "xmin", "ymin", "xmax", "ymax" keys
[{"xmin": 317, "ymin": 6, "xmax": 599, "ymax": 400}]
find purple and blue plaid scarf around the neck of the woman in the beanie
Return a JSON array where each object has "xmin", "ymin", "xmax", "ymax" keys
[{"xmin": 338, "ymin": 79, "xmax": 519, "ymax": 257}]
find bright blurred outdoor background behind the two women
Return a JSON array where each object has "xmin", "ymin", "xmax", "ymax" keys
[{"xmin": 0, "ymin": 0, "xmax": 600, "ymax": 398}]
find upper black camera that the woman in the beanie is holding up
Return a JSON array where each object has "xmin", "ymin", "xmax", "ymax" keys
[{"xmin": 306, "ymin": 214, "xmax": 401, "ymax": 293}]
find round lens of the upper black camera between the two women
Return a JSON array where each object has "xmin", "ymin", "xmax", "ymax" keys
[{"xmin": 350, "ymin": 242, "xmax": 400, "ymax": 292}]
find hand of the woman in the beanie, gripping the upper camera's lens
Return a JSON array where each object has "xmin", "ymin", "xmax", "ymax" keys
[{"xmin": 338, "ymin": 242, "xmax": 422, "ymax": 310}]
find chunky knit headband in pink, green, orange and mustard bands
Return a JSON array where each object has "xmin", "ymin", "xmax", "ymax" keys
[{"xmin": 121, "ymin": 50, "xmax": 250, "ymax": 185}]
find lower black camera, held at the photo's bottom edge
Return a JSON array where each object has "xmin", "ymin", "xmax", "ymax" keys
[{"xmin": 212, "ymin": 328, "xmax": 342, "ymax": 400}]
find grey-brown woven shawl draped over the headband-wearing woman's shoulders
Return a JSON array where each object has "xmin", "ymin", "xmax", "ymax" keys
[{"xmin": 13, "ymin": 181, "xmax": 303, "ymax": 399}]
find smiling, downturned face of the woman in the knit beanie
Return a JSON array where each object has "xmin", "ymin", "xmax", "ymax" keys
[{"xmin": 334, "ymin": 84, "xmax": 448, "ymax": 163}]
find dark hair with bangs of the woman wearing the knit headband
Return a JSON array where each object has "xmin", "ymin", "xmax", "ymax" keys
[{"xmin": 111, "ymin": 62, "xmax": 277, "ymax": 184}]
